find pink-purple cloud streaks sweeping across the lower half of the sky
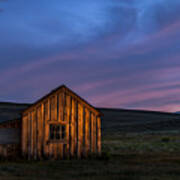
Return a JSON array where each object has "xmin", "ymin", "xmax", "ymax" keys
[{"xmin": 0, "ymin": 17, "xmax": 180, "ymax": 111}]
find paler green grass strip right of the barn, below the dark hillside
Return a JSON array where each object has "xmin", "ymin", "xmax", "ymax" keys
[{"xmin": 103, "ymin": 132, "xmax": 180, "ymax": 155}]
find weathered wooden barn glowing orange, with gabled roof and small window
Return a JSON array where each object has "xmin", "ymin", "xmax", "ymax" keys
[{"xmin": 0, "ymin": 85, "xmax": 101, "ymax": 159}]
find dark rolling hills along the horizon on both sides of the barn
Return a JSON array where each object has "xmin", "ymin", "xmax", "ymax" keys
[{"xmin": 0, "ymin": 102, "xmax": 180, "ymax": 134}]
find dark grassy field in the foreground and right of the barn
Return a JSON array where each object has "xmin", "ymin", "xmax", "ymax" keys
[{"xmin": 0, "ymin": 132, "xmax": 180, "ymax": 180}]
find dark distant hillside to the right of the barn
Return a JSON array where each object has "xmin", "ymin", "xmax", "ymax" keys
[{"xmin": 97, "ymin": 108, "xmax": 180, "ymax": 134}]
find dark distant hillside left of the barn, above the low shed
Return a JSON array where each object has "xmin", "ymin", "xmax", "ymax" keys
[{"xmin": 0, "ymin": 102, "xmax": 29, "ymax": 122}]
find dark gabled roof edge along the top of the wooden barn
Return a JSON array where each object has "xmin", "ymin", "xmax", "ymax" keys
[{"xmin": 23, "ymin": 84, "xmax": 103, "ymax": 116}]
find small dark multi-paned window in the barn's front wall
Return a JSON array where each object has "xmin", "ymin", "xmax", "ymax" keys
[{"xmin": 49, "ymin": 124, "xmax": 66, "ymax": 140}]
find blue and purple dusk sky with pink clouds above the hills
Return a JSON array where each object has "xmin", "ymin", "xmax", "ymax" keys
[{"xmin": 0, "ymin": 0, "xmax": 180, "ymax": 112}]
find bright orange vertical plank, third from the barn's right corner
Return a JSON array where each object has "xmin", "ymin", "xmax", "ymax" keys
[{"xmin": 85, "ymin": 108, "xmax": 90, "ymax": 156}]
